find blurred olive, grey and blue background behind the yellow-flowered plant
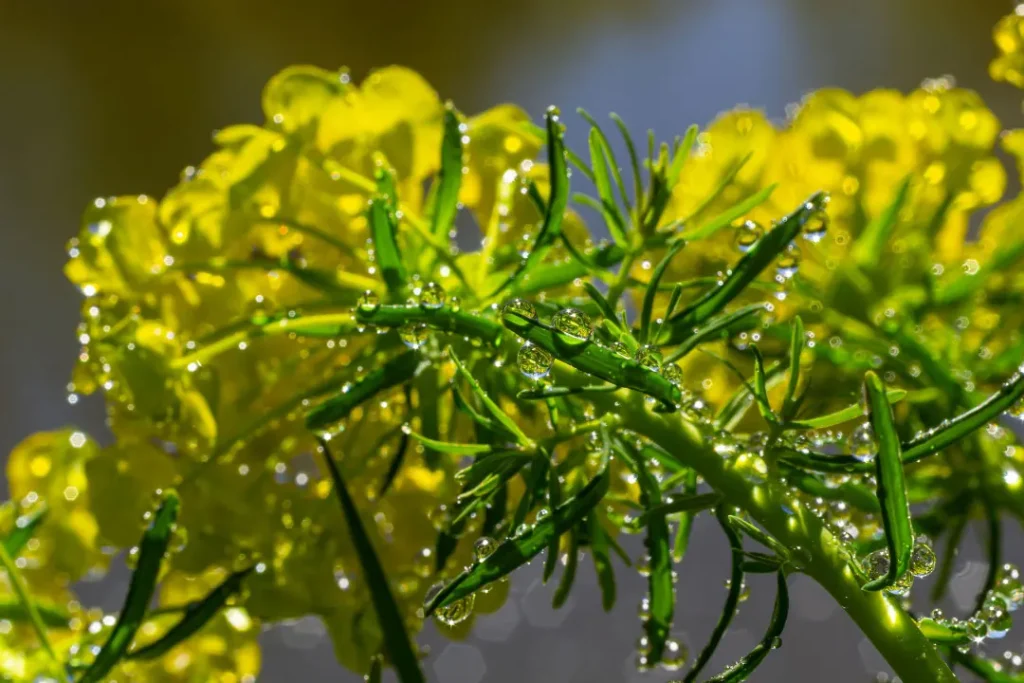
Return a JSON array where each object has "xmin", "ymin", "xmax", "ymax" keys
[{"xmin": 0, "ymin": 0, "xmax": 1024, "ymax": 683}]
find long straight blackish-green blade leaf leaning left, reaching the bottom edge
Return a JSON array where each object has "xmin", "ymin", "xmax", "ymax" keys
[{"xmin": 319, "ymin": 439, "xmax": 425, "ymax": 683}]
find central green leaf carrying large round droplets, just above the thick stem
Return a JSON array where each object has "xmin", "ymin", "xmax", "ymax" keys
[{"xmin": 503, "ymin": 313, "xmax": 682, "ymax": 408}]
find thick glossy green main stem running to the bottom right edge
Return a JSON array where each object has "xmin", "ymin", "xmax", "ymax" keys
[{"xmin": 593, "ymin": 392, "xmax": 957, "ymax": 683}]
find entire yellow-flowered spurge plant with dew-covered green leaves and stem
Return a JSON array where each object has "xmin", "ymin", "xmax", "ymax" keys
[{"xmin": 9, "ymin": 6, "xmax": 1024, "ymax": 683}]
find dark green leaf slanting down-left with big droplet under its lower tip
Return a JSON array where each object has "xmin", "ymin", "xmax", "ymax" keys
[{"xmin": 426, "ymin": 469, "xmax": 608, "ymax": 615}]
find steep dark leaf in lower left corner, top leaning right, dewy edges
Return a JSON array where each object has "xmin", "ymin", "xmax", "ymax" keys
[{"xmin": 79, "ymin": 493, "xmax": 179, "ymax": 683}]
